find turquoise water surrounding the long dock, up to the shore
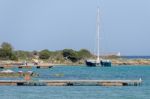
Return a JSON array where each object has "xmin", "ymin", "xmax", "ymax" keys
[{"xmin": 0, "ymin": 66, "xmax": 150, "ymax": 99}]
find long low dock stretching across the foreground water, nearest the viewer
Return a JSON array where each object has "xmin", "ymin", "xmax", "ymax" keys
[{"xmin": 0, "ymin": 79, "xmax": 142, "ymax": 86}]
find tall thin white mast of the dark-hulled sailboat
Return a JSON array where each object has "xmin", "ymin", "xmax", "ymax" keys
[{"xmin": 97, "ymin": 7, "xmax": 100, "ymax": 62}]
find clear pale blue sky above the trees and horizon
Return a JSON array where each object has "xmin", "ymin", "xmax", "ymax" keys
[{"xmin": 0, "ymin": 0, "xmax": 150, "ymax": 55}]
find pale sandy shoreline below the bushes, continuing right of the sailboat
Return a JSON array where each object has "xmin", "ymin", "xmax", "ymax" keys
[{"xmin": 0, "ymin": 58, "xmax": 150, "ymax": 67}]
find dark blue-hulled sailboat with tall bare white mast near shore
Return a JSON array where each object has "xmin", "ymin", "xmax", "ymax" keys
[{"xmin": 85, "ymin": 7, "xmax": 111, "ymax": 67}]
